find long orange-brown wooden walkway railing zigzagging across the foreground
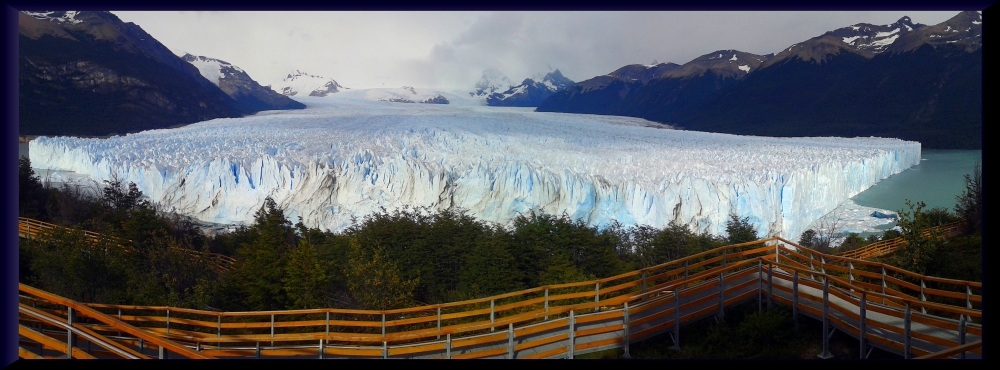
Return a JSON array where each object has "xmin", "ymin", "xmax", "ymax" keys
[{"xmin": 22, "ymin": 234, "xmax": 982, "ymax": 358}]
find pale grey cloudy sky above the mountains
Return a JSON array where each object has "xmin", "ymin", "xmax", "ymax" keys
[{"xmin": 113, "ymin": 10, "xmax": 958, "ymax": 91}]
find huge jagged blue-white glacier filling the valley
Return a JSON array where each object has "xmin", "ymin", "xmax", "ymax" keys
[{"xmin": 29, "ymin": 92, "xmax": 921, "ymax": 239}]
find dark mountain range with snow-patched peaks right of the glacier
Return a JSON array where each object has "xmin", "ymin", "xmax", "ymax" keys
[{"xmin": 537, "ymin": 11, "xmax": 983, "ymax": 149}]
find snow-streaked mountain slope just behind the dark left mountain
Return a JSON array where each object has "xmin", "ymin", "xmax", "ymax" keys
[{"xmin": 172, "ymin": 50, "xmax": 305, "ymax": 112}]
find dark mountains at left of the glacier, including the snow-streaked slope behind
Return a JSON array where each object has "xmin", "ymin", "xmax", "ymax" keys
[{"xmin": 18, "ymin": 11, "xmax": 305, "ymax": 136}]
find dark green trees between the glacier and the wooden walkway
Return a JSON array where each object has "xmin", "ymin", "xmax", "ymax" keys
[{"xmin": 19, "ymin": 158, "xmax": 981, "ymax": 311}]
